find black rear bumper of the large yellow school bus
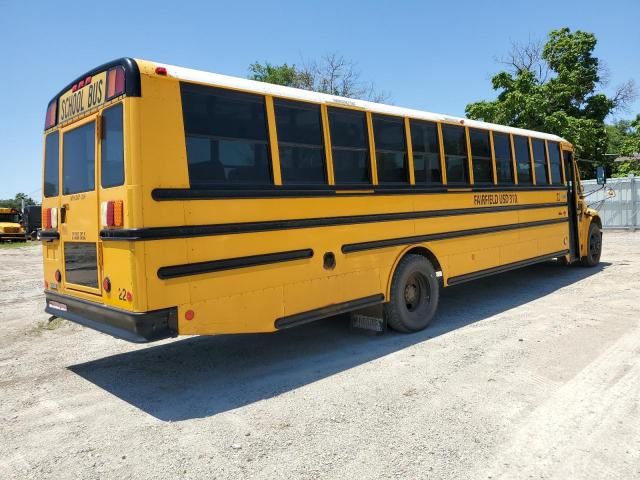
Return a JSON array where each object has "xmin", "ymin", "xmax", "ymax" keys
[{"xmin": 45, "ymin": 292, "xmax": 178, "ymax": 343}]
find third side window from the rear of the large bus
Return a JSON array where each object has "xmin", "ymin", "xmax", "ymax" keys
[{"xmin": 329, "ymin": 108, "xmax": 371, "ymax": 184}]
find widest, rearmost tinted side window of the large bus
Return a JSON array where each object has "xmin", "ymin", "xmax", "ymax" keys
[{"xmin": 180, "ymin": 83, "xmax": 272, "ymax": 187}]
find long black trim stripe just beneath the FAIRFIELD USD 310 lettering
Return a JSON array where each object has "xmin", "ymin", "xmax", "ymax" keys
[{"xmin": 100, "ymin": 202, "xmax": 566, "ymax": 241}]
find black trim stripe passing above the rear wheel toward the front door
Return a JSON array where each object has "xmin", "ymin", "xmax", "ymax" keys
[{"xmin": 342, "ymin": 218, "xmax": 567, "ymax": 253}]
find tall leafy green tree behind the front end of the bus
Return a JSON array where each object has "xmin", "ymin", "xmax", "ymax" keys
[{"xmin": 465, "ymin": 28, "xmax": 635, "ymax": 175}]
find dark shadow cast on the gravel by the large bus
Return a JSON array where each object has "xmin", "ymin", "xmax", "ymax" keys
[{"xmin": 68, "ymin": 263, "xmax": 610, "ymax": 421}]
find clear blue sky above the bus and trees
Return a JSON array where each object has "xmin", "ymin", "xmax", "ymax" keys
[{"xmin": 0, "ymin": 0, "xmax": 640, "ymax": 199}]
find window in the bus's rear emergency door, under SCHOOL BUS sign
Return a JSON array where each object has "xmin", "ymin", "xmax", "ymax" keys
[{"xmin": 62, "ymin": 122, "xmax": 96, "ymax": 195}]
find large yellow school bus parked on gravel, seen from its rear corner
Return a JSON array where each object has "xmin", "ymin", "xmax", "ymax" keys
[{"xmin": 41, "ymin": 58, "xmax": 602, "ymax": 342}]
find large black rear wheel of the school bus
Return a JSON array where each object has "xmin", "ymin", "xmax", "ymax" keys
[{"xmin": 384, "ymin": 254, "xmax": 440, "ymax": 333}]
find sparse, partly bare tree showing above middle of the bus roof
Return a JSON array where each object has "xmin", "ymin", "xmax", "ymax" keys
[{"xmin": 249, "ymin": 53, "xmax": 389, "ymax": 102}]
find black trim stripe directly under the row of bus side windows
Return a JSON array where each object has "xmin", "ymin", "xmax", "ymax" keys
[{"xmin": 151, "ymin": 185, "xmax": 567, "ymax": 201}]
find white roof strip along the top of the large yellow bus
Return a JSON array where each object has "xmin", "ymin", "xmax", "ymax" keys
[{"xmin": 152, "ymin": 62, "xmax": 567, "ymax": 142}]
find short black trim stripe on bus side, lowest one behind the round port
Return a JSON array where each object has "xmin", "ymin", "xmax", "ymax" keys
[{"xmin": 158, "ymin": 248, "xmax": 313, "ymax": 280}]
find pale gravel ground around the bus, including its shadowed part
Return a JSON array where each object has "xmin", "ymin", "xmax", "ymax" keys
[{"xmin": 0, "ymin": 232, "xmax": 640, "ymax": 479}]
